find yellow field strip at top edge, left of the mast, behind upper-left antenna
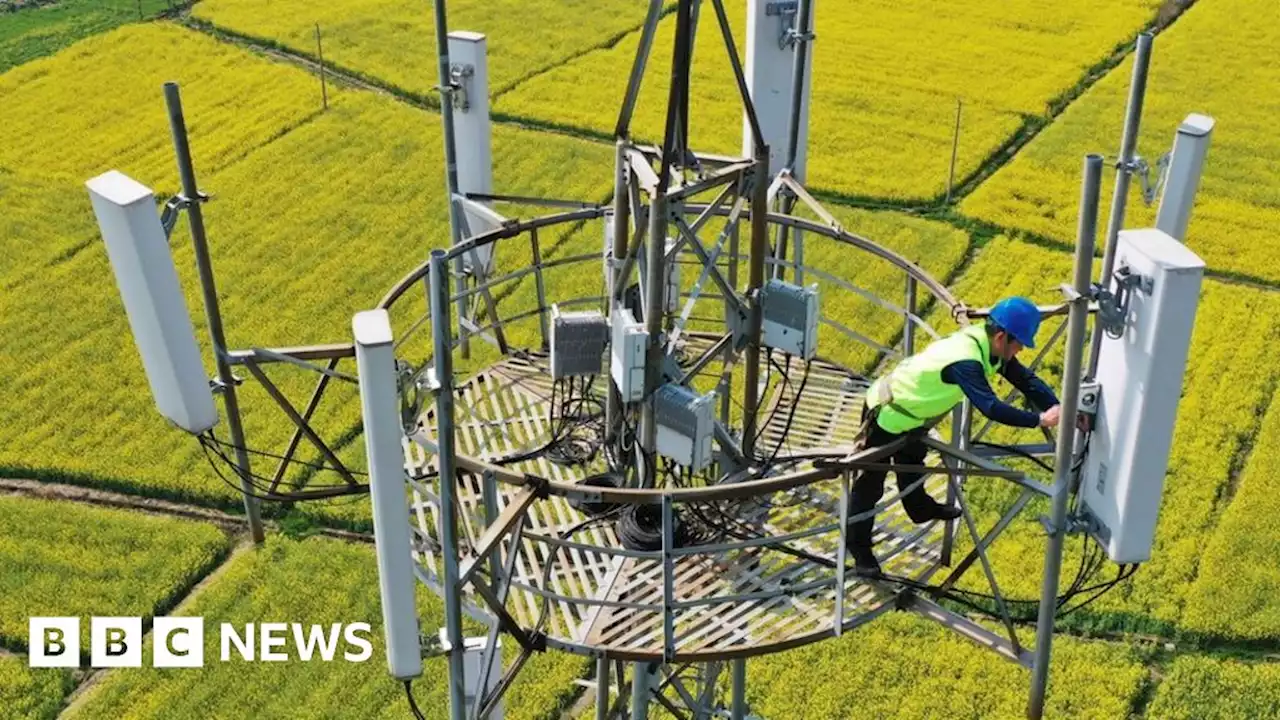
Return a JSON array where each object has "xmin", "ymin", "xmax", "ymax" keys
[{"xmin": 192, "ymin": 0, "xmax": 665, "ymax": 101}]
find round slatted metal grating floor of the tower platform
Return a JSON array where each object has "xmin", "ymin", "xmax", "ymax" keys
[{"xmin": 406, "ymin": 338, "xmax": 946, "ymax": 660}]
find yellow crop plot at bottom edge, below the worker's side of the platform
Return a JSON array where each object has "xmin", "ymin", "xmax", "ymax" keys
[{"xmin": 746, "ymin": 612, "xmax": 1144, "ymax": 720}]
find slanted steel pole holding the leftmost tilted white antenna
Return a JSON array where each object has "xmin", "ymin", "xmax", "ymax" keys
[{"xmin": 164, "ymin": 82, "xmax": 265, "ymax": 544}]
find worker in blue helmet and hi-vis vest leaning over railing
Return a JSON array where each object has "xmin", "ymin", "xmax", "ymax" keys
[{"xmin": 845, "ymin": 297, "xmax": 1061, "ymax": 575}]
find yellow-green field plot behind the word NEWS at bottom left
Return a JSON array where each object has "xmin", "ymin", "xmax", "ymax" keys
[{"xmin": 64, "ymin": 537, "xmax": 586, "ymax": 720}]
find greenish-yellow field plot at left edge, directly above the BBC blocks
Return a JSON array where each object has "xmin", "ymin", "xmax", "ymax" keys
[{"xmin": 0, "ymin": 496, "xmax": 230, "ymax": 657}]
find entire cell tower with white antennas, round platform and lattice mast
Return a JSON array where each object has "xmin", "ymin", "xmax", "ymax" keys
[{"xmin": 88, "ymin": 0, "xmax": 1212, "ymax": 720}]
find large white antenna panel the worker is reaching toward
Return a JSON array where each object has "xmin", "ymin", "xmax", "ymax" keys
[{"xmin": 1080, "ymin": 229, "xmax": 1204, "ymax": 564}]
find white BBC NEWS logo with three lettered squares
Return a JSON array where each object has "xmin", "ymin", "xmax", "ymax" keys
[{"xmin": 27, "ymin": 618, "xmax": 374, "ymax": 667}]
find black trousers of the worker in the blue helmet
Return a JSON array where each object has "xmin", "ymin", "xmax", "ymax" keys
[{"xmin": 849, "ymin": 410, "xmax": 938, "ymax": 547}]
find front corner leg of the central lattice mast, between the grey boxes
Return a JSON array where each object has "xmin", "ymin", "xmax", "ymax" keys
[{"xmin": 640, "ymin": 190, "xmax": 667, "ymax": 488}]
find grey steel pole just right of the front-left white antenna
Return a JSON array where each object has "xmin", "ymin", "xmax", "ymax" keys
[{"xmin": 431, "ymin": 250, "xmax": 467, "ymax": 720}]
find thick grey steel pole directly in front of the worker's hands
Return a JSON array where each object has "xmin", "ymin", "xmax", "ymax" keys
[{"xmin": 1027, "ymin": 155, "xmax": 1102, "ymax": 720}]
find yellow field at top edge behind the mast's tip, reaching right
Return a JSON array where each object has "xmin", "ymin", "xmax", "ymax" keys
[{"xmin": 497, "ymin": 0, "xmax": 1160, "ymax": 200}]
